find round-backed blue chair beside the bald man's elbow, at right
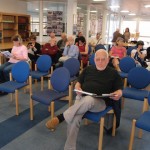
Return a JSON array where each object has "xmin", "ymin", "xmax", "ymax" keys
[{"xmin": 123, "ymin": 67, "xmax": 150, "ymax": 111}]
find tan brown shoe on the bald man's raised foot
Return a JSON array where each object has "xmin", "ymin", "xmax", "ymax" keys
[{"xmin": 46, "ymin": 117, "xmax": 59, "ymax": 131}]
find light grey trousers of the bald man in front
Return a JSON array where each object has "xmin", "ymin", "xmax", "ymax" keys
[{"xmin": 63, "ymin": 96, "xmax": 106, "ymax": 150}]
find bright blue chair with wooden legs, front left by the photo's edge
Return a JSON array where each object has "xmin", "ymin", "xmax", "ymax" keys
[{"xmin": 0, "ymin": 61, "xmax": 32, "ymax": 115}]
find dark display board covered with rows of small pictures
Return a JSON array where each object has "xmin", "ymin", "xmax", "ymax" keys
[{"xmin": 47, "ymin": 11, "xmax": 63, "ymax": 36}]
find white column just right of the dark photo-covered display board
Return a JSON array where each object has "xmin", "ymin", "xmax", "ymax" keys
[{"xmin": 67, "ymin": 0, "xmax": 77, "ymax": 35}]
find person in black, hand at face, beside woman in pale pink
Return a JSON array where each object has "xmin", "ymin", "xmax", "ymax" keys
[{"xmin": 27, "ymin": 35, "xmax": 41, "ymax": 62}]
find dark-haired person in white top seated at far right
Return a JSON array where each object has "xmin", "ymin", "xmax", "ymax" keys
[{"xmin": 131, "ymin": 41, "xmax": 147, "ymax": 68}]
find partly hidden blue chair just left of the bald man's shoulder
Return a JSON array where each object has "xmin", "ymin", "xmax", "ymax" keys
[{"xmin": 63, "ymin": 58, "xmax": 80, "ymax": 105}]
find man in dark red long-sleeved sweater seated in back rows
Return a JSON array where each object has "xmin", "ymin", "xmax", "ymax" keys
[{"xmin": 42, "ymin": 40, "xmax": 58, "ymax": 64}]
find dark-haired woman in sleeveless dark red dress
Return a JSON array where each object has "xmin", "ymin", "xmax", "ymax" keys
[{"xmin": 78, "ymin": 36, "xmax": 88, "ymax": 67}]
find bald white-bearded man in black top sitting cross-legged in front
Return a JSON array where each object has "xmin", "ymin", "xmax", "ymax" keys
[{"xmin": 46, "ymin": 49, "xmax": 123, "ymax": 150}]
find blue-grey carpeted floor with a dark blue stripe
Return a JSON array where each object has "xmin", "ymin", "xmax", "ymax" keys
[{"xmin": 0, "ymin": 84, "xmax": 150, "ymax": 150}]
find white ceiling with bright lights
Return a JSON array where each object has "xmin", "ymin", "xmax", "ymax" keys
[{"xmin": 19, "ymin": 0, "xmax": 150, "ymax": 17}]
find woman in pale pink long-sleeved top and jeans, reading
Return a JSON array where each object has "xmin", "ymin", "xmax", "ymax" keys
[{"xmin": 0, "ymin": 35, "xmax": 28, "ymax": 83}]
